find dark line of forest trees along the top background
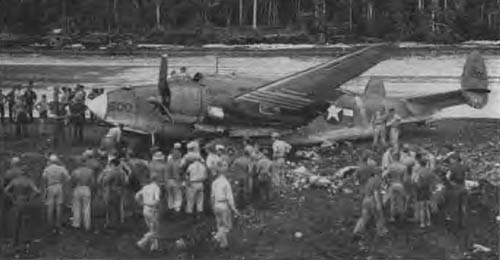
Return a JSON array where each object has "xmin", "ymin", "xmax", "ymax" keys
[{"xmin": 0, "ymin": 0, "xmax": 500, "ymax": 42}]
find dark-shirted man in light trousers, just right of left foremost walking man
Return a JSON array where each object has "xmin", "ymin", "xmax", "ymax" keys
[{"xmin": 163, "ymin": 143, "xmax": 182, "ymax": 213}]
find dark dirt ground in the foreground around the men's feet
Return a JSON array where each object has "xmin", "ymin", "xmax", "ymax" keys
[{"xmin": 0, "ymin": 120, "xmax": 500, "ymax": 259}]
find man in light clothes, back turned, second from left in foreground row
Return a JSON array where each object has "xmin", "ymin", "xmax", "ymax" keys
[{"xmin": 42, "ymin": 154, "xmax": 71, "ymax": 233}]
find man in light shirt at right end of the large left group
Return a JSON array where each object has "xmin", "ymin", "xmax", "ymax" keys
[{"xmin": 272, "ymin": 133, "xmax": 292, "ymax": 189}]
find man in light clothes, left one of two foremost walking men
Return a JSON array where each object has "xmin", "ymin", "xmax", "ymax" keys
[{"xmin": 135, "ymin": 175, "xmax": 161, "ymax": 251}]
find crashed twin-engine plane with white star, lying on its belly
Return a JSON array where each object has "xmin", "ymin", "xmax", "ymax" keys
[{"xmin": 87, "ymin": 44, "xmax": 489, "ymax": 144}]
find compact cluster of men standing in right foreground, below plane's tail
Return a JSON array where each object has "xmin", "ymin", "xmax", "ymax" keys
[{"xmin": 354, "ymin": 140, "xmax": 468, "ymax": 241}]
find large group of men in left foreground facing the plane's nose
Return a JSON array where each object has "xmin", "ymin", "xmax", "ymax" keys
[{"xmin": 1, "ymin": 127, "xmax": 291, "ymax": 250}]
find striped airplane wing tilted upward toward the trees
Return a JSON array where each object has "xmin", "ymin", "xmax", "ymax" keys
[{"xmin": 235, "ymin": 44, "xmax": 390, "ymax": 111}]
